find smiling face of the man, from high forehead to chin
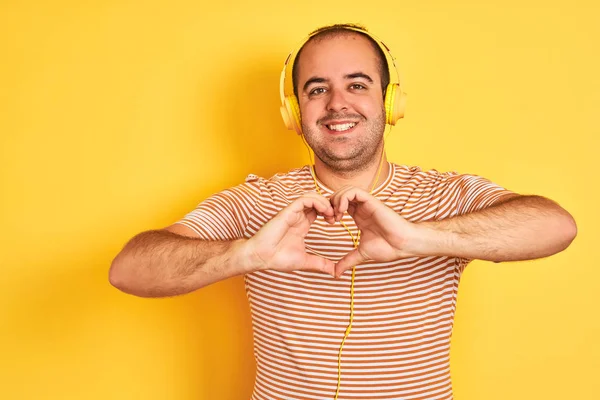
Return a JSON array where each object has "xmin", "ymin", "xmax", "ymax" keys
[{"xmin": 297, "ymin": 33, "xmax": 385, "ymax": 172}]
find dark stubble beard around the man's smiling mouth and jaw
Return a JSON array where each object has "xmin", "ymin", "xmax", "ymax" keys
[{"xmin": 302, "ymin": 108, "xmax": 385, "ymax": 175}]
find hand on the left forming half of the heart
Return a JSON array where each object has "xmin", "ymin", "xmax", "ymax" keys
[{"xmin": 246, "ymin": 193, "xmax": 335, "ymax": 276}]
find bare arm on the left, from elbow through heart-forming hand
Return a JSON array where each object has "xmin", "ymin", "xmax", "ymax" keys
[{"xmin": 109, "ymin": 193, "xmax": 334, "ymax": 297}]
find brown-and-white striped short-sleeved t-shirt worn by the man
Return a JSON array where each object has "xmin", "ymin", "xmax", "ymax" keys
[{"xmin": 179, "ymin": 163, "xmax": 512, "ymax": 400}]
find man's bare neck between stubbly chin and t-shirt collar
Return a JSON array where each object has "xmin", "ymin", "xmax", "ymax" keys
[{"xmin": 315, "ymin": 153, "xmax": 390, "ymax": 192}]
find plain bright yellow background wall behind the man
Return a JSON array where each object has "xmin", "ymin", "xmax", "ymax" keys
[{"xmin": 0, "ymin": 0, "xmax": 600, "ymax": 400}]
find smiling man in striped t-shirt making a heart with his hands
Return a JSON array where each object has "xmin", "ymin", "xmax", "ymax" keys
[{"xmin": 110, "ymin": 25, "xmax": 576, "ymax": 400}]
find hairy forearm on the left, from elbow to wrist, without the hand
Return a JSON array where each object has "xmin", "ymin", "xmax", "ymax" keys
[{"xmin": 109, "ymin": 231, "xmax": 251, "ymax": 297}]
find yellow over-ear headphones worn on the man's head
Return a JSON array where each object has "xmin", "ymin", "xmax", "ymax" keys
[{"xmin": 279, "ymin": 25, "xmax": 406, "ymax": 135}]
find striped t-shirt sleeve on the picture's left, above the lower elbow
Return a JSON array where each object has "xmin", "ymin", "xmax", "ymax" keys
[{"xmin": 171, "ymin": 175, "xmax": 260, "ymax": 240}]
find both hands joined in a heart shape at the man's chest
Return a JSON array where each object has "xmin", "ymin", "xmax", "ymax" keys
[{"xmin": 250, "ymin": 186, "xmax": 421, "ymax": 278}]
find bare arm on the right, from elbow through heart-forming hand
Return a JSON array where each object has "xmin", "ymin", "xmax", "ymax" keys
[{"xmin": 331, "ymin": 187, "xmax": 577, "ymax": 276}]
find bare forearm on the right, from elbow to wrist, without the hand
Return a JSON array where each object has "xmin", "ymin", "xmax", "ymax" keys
[{"xmin": 417, "ymin": 196, "xmax": 577, "ymax": 262}]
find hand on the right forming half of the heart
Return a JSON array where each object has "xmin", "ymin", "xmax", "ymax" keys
[{"xmin": 330, "ymin": 186, "xmax": 419, "ymax": 277}]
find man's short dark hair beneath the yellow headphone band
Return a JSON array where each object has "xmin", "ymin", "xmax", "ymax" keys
[{"xmin": 292, "ymin": 24, "xmax": 390, "ymax": 98}]
